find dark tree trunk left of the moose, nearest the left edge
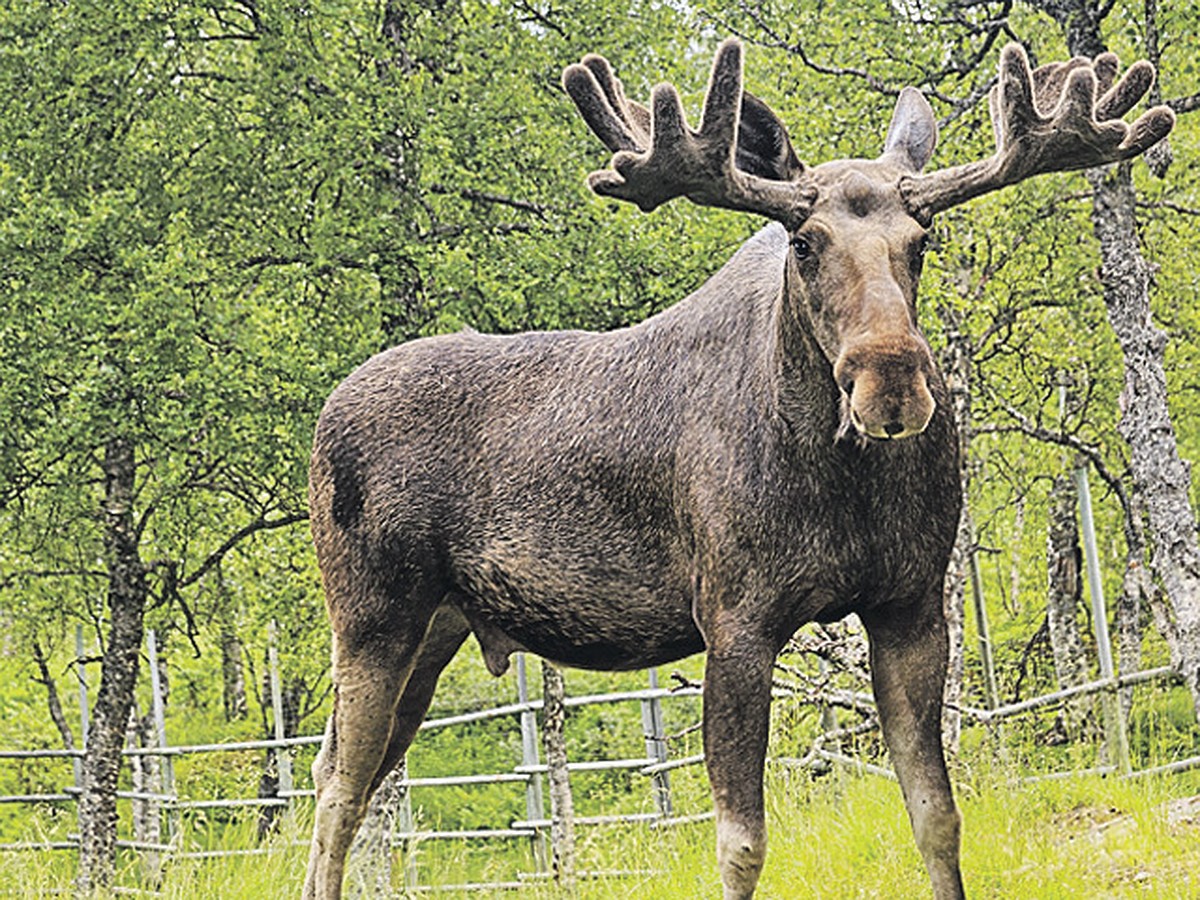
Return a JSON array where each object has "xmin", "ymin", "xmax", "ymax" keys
[{"xmin": 77, "ymin": 438, "xmax": 146, "ymax": 894}]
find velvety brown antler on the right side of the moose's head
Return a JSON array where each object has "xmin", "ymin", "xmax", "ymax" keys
[{"xmin": 900, "ymin": 43, "xmax": 1175, "ymax": 222}]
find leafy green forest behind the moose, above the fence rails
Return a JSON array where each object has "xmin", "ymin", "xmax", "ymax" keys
[{"xmin": 0, "ymin": 0, "xmax": 1200, "ymax": 897}]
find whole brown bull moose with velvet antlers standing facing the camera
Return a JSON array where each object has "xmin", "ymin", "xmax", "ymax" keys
[{"xmin": 304, "ymin": 40, "xmax": 1174, "ymax": 900}]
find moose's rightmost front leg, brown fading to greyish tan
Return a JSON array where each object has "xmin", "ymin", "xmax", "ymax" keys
[{"xmin": 863, "ymin": 600, "xmax": 964, "ymax": 900}]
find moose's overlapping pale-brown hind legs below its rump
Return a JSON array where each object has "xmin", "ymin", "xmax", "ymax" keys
[{"xmin": 304, "ymin": 604, "xmax": 441, "ymax": 900}]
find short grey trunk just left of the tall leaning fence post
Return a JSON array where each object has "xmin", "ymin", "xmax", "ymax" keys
[{"xmin": 1046, "ymin": 474, "xmax": 1092, "ymax": 739}]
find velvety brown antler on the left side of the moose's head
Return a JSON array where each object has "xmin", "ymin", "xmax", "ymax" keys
[{"xmin": 563, "ymin": 40, "xmax": 816, "ymax": 223}]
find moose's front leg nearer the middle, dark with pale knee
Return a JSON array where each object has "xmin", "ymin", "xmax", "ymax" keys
[{"xmin": 704, "ymin": 636, "xmax": 775, "ymax": 900}]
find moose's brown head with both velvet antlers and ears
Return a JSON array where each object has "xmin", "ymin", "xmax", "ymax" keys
[{"xmin": 563, "ymin": 40, "xmax": 1175, "ymax": 439}]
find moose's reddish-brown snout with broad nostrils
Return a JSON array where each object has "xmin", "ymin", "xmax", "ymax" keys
[{"xmin": 834, "ymin": 338, "xmax": 936, "ymax": 440}]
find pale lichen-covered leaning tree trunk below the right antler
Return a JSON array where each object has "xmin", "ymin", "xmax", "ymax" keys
[{"xmin": 1088, "ymin": 164, "xmax": 1200, "ymax": 719}]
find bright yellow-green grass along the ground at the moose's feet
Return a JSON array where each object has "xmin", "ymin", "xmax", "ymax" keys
[{"xmin": 0, "ymin": 763, "xmax": 1200, "ymax": 900}]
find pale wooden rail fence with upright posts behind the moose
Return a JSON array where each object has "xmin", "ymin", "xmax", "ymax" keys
[{"xmin": 0, "ymin": 469, "xmax": 1200, "ymax": 890}]
